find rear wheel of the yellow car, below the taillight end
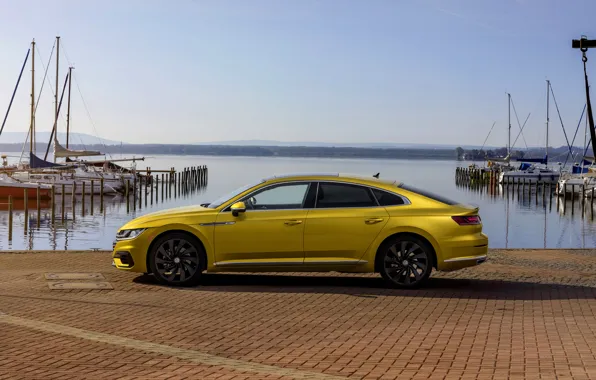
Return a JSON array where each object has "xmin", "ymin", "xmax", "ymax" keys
[{"xmin": 377, "ymin": 235, "xmax": 433, "ymax": 289}]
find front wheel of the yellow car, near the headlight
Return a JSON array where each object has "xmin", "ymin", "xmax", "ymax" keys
[{"xmin": 149, "ymin": 232, "xmax": 206, "ymax": 286}]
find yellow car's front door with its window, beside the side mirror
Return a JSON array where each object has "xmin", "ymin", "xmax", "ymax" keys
[{"xmin": 215, "ymin": 182, "xmax": 310, "ymax": 267}]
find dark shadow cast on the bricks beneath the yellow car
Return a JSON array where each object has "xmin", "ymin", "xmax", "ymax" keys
[{"xmin": 134, "ymin": 273, "xmax": 596, "ymax": 300}]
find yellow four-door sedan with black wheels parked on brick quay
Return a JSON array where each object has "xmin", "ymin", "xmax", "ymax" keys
[{"xmin": 112, "ymin": 174, "xmax": 488, "ymax": 288}]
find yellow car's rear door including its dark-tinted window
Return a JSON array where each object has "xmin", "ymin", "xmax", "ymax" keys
[{"xmin": 304, "ymin": 182, "xmax": 389, "ymax": 265}]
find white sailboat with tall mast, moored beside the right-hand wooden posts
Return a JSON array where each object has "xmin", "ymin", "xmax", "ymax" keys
[{"xmin": 499, "ymin": 80, "xmax": 561, "ymax": 183}]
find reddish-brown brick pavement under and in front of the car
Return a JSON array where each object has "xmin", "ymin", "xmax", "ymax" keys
[{"xmin": 0, "ymin": 250, "xmax": 596, "ymax": 379}]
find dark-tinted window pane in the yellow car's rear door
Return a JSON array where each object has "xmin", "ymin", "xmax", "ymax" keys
[{"xmin": 316, "ymin": 182, "xmax": 377, "ymax": 208}]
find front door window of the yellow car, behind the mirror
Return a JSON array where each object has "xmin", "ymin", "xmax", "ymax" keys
[{"xmin": 244, "ymin": 183, "xmax": 308, "ymax": 210}]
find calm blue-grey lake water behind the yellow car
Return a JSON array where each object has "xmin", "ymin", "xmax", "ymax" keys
[{"xmin": 0, "ymin": 155, "xmax": 596, "ymax": 250}]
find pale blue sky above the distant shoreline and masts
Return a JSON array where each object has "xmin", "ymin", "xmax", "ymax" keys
[{"xmin": 0, "ymin": 0, "xmax": 596, "ymax": 146}]
